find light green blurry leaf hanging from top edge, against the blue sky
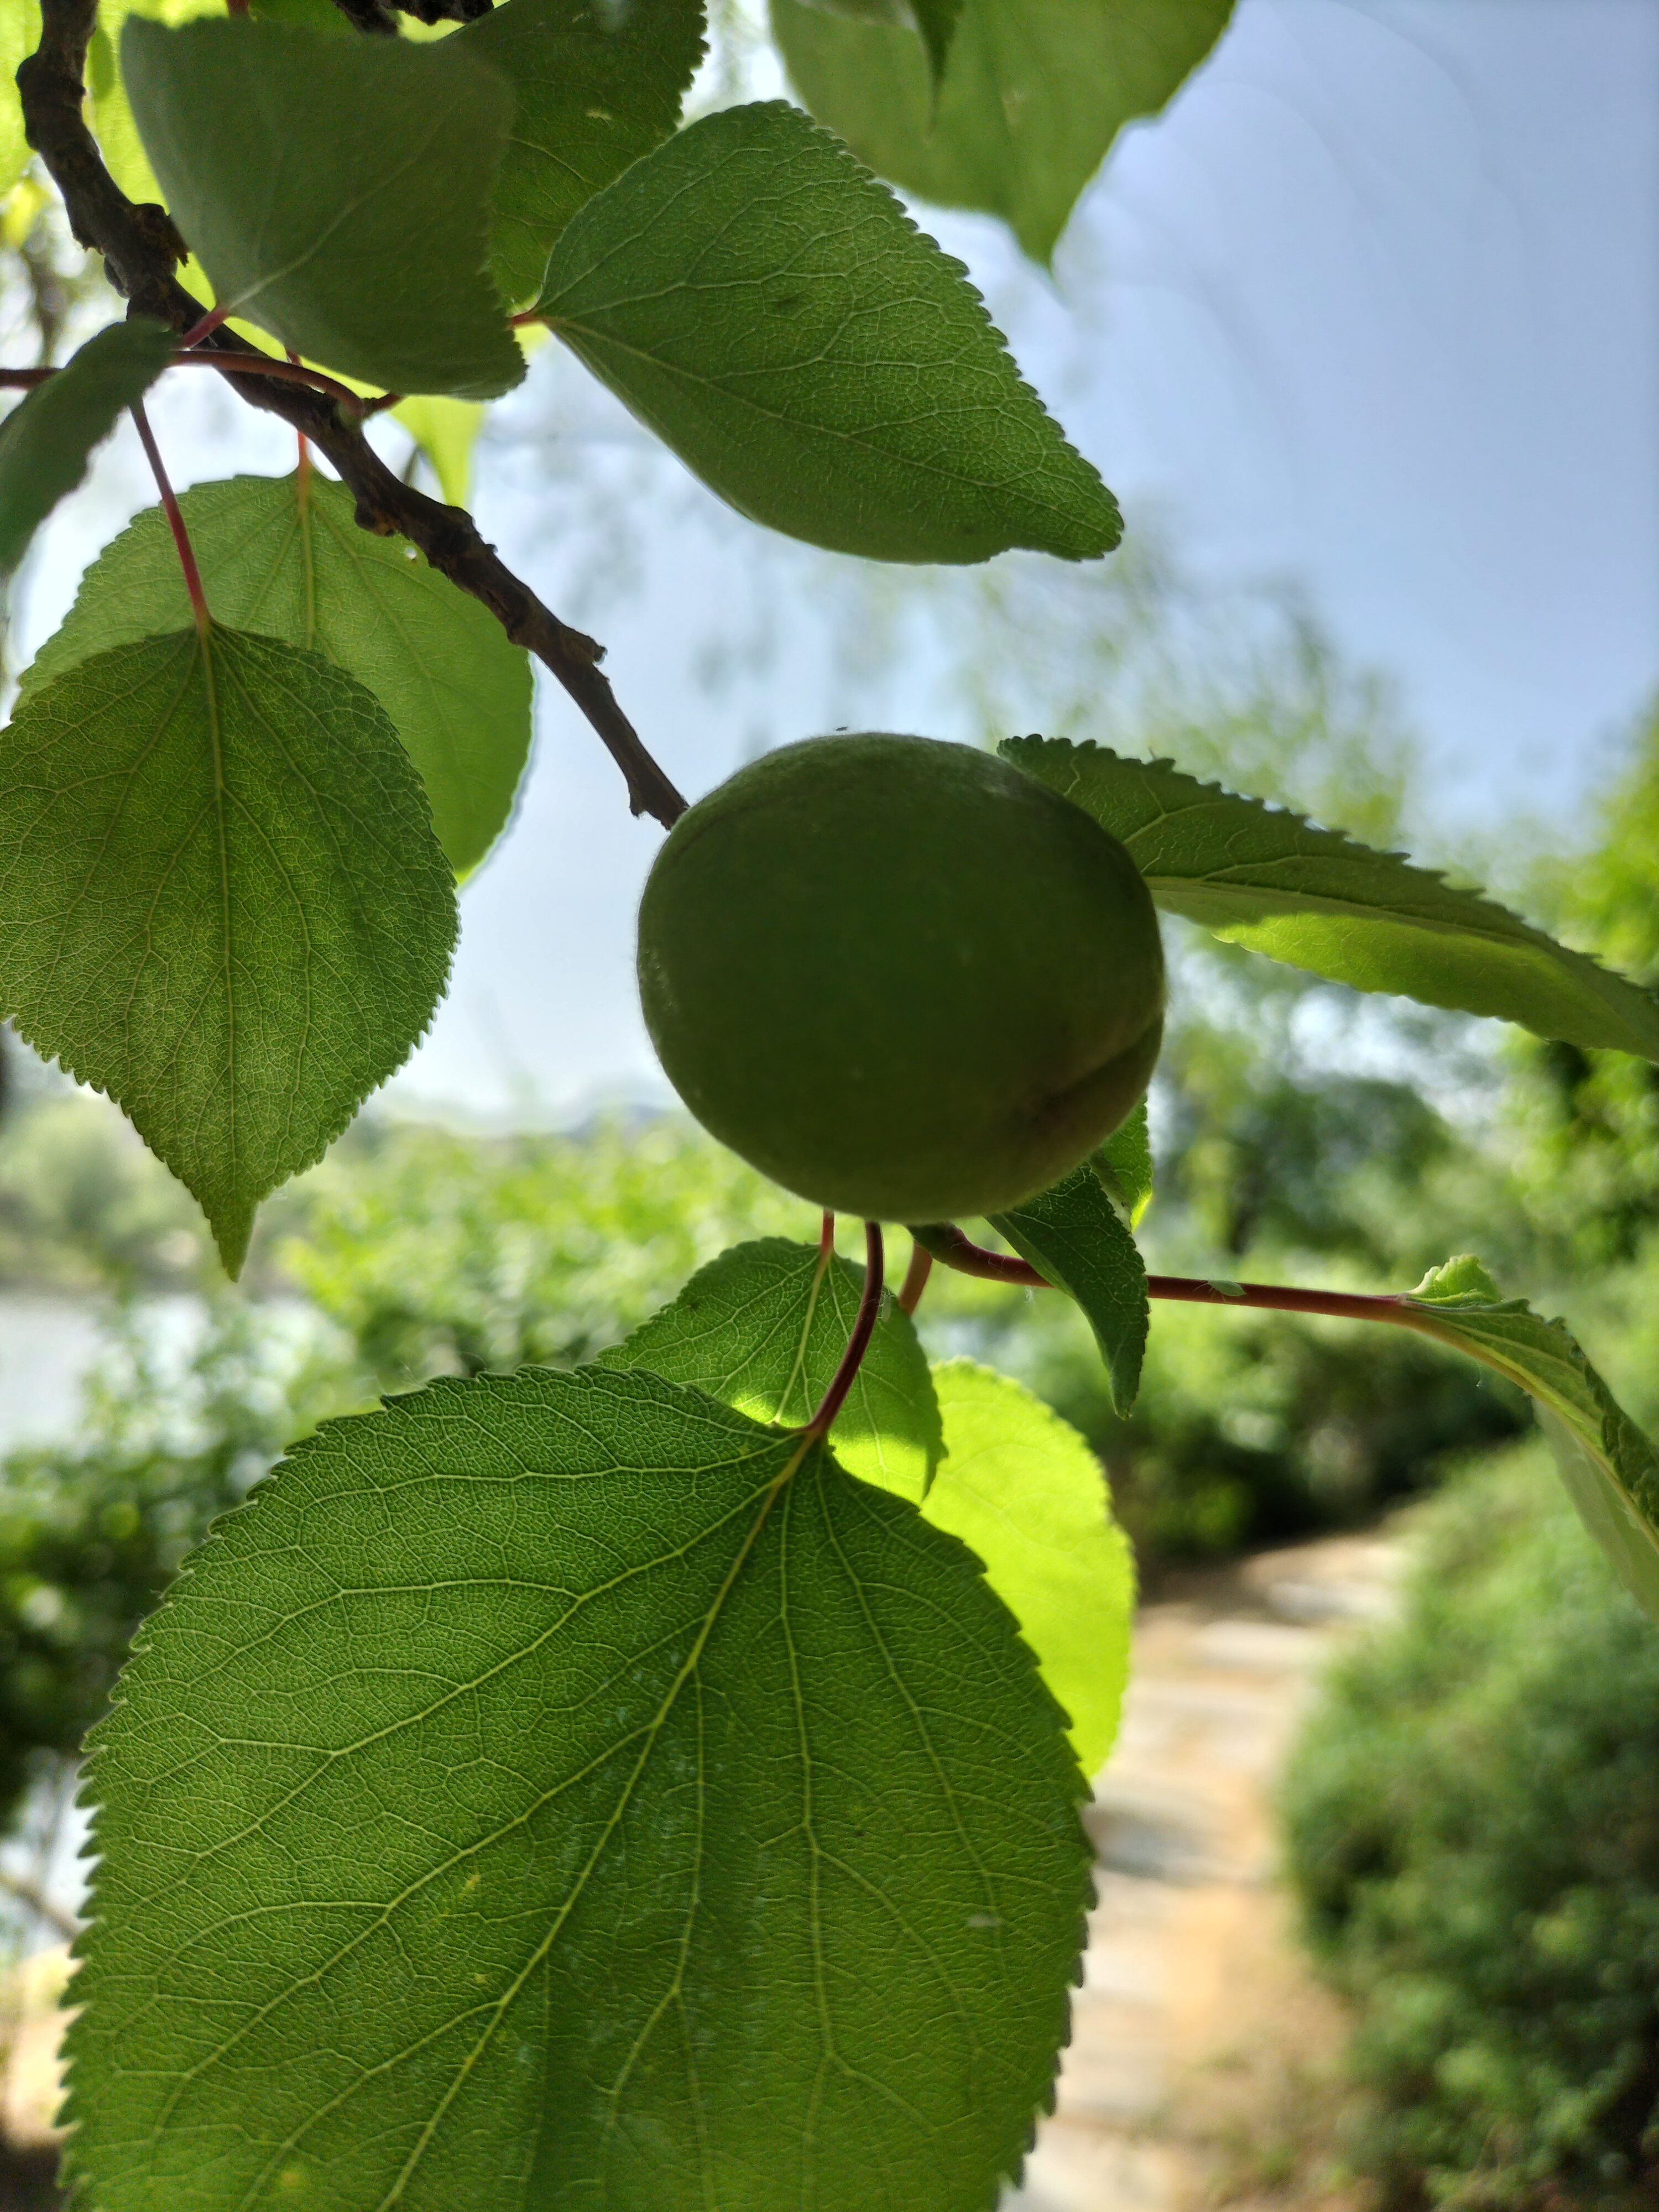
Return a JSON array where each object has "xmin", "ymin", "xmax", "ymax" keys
[{"xmin": 772, "ymin": 0, "xmax": 1232, "ymax": 263}]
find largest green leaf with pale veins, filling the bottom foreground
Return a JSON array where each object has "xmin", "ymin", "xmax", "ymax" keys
[{"xmin": 69, "ymin": 1367, "xmax": 1091, "ymax": 2212}]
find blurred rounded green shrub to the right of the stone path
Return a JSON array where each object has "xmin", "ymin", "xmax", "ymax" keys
[{"xmin": 1283, "ymin": 1447, "xmax": 1659, "ymax": 2212}]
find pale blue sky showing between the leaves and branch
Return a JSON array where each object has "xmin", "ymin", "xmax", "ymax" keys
[{"xmin": 22, "ymin": 0, "xmax": 1659, "ymax": 1113}]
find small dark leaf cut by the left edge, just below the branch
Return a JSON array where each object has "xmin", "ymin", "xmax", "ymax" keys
[{"xmin": 0, "ymin": 321, "xmax": 179, "ymax": 575}]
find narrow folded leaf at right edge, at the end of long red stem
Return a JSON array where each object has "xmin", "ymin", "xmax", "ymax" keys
[{"xmin": 1400, "ymin": 1254, "xmax": 1659, "ymax": 1621}]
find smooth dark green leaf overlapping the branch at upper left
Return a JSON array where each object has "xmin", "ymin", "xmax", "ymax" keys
[{"xmin": 122, "ymin": 15, "xmax": 524, "ymax": 400}]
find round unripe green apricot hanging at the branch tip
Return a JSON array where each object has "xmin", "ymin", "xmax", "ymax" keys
[{"xmin": 639, "ymin": 737, "xmax": 1164, "ymax": 1221}]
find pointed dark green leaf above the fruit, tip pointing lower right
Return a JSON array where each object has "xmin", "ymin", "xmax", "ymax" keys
[{"xmin": 538, "ymin": 100, "xmax": 1121, "ymax": 562}]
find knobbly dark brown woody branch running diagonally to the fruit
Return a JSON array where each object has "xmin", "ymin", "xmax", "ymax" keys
[{"xmin": 18, "ymin": 0, "xmax": 686, "ymax": 827}]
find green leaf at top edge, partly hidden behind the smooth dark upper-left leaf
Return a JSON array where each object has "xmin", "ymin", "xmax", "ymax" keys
[{"xmin": 458, "ymin": 0, "xmax": 703, "ymax": 303}]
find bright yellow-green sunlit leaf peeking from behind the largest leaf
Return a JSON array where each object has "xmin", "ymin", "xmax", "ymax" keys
[{"xmin": 925, "ymin": 1360, "xmax": 1135, "ymax": 1774}]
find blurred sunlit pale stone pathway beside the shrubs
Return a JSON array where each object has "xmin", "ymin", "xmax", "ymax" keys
[{"xmin": 0, "ymin": 1537, "xmax": 1402, "ymax": 2212}]
